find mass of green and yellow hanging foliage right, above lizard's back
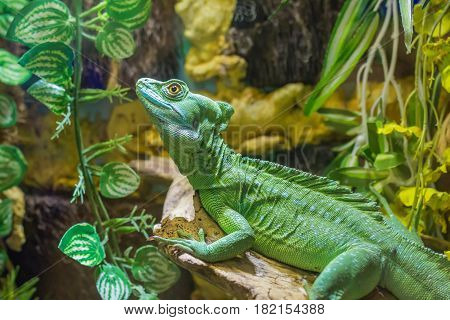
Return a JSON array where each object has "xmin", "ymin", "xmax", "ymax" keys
[{"xmin": 298, "ymin": 0, "xmax": 450, "ymax": 254}]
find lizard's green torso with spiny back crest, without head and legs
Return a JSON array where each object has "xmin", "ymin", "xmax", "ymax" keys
[{"xmin": 200, "ymin": 158, "xmax": 450, "ymax": 299}]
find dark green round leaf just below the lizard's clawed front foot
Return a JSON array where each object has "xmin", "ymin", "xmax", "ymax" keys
[{"xmin": 131, "ymin": 245, "xmax": 180, "ymax": 292}]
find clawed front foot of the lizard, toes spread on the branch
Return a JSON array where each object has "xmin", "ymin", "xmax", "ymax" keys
[{"xmin": 151, "ymin": 229, "xmax": 207, "ymax": 258}]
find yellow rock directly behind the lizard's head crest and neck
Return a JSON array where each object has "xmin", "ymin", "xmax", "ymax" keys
[{"xmin": 217, "ymin": 83, "xmax": 330, "ymax": 154}]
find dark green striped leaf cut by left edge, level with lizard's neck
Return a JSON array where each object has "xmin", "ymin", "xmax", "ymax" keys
[{"xmin": 0, "ymin": 145, "xmax": 28, "ymax": 192}]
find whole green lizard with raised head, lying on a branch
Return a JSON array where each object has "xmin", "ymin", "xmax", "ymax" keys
[{"xmin": 136, "ymin": 79, "xmax": 450, "ymax": 299}]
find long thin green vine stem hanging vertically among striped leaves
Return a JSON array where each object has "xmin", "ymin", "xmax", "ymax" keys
[{"xmin": 72, "ymin": 0, "xmax": 120, "ymax": 263}]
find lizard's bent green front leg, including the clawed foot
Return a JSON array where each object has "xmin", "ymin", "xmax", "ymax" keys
[{"xmin": 154, "ymin": 208, "xmax": 255, "ymax": 262}]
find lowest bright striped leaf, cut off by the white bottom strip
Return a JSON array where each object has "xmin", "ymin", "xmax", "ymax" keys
[{"xmin": 96, "ymin": 264, "xmax": 131, "ymax": 300}]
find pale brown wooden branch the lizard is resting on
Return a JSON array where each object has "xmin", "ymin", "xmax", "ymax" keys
[{"xmin": 133, "ymin": 158, "xmax": 392, "ymax": 300}]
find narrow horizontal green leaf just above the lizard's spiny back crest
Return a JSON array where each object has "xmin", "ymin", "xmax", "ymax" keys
[{"xmin": 329, "ymin": 167, "xmax": 389, "ymax": 187}]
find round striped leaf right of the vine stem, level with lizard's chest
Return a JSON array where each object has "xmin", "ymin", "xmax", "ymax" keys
[{"xmin": 100, "ymin": 162, "xmax": 141, "ymax": 199}]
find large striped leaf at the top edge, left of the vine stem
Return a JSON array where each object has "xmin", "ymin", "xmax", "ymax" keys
[{"xmin": 7, "ymin": 0, "xmax": 75, "ymax": 47}]
